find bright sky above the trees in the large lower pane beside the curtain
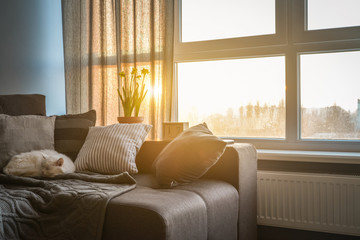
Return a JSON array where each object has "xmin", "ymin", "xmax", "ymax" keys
[{"xmin": 178, "ymin": 56, "xmax": 285, "ymax": 115}]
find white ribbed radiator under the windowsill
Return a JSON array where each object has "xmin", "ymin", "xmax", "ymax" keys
[{"xmin": 257, "ymin": 171, "xmax": 360, "ymax": 236}]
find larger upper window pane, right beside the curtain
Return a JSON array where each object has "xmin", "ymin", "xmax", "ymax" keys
[{"xmin": 181, "ymin": 0, "xmax": 275, "ymax": 42}]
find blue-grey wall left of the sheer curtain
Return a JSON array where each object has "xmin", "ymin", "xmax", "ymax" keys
[{"xmin": 0, "ymin": 0, "xmax": 66, "ymax": 115}]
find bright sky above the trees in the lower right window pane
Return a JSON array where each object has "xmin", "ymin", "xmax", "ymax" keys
[{"xmin": 300, "ymin": 51, "xmax": 360, "ymax": 112}]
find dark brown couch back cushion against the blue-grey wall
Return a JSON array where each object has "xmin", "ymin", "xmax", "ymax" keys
[{"xmin": 0, "ymin": 94, "xmax": 46, "ymax": 116}]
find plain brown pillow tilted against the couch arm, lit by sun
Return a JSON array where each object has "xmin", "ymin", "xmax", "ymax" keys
[{"xmin": 153, "ymin": 123, "xmax": 226, "ymax": 187}]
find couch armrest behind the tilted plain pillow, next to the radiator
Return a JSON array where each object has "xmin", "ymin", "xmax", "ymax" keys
[{"xmin": 136, "ymin": 141, "xmax": 257, "ymax": 240}]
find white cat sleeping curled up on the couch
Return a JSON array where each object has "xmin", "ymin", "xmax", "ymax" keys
[{"xmin": 3, "ymin": 149, "xmax": 75, "ymax": 177}]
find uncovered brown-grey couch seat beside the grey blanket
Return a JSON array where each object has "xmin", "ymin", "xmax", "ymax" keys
[{"xmin": 103, "ymin": 174, "xmax": 238, "ymax": 240}]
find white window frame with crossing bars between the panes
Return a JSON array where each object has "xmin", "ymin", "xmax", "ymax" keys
[{"xmin": 173, "ymin": 0, "xmax": 360, "ymax": 152}]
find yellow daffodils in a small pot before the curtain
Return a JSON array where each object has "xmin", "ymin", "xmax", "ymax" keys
[{"xmin": 117, "ymin": 67, "xmax": 149, "ymax": 123}]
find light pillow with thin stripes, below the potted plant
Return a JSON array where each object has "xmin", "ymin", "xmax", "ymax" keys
[{"xmin": 75, "ymin": 124, "xmax": 152, "ymax": 174}]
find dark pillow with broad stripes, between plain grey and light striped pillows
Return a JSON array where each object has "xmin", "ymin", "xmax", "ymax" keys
[{"xmin": 55, "ymin": 110, "xmax": 96, "ymax": 161}]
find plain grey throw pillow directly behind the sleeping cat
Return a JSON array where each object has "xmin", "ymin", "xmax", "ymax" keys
[{"xmin": 0, "ymin": 114, "xmax": 55, "ymax": 171}]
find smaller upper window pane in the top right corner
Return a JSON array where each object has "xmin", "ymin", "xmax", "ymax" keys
[{"xmin": 308, "ymin": 0, "xmax": 360, "ymax": 30}]
